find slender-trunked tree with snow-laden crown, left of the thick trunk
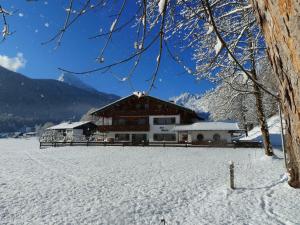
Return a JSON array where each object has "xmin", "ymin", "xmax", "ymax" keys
[{"xmin": 159, "ymin": 0, "xmax": 276, "ymax": 156}]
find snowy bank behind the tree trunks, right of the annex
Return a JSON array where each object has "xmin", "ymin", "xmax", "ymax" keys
[{"xmin": 242, "ymin": 115, "xmax": 282, "ymax": 147}]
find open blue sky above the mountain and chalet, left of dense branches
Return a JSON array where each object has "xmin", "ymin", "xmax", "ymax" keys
[{"xmin": 0, "ymin": 0, "xmax": 213, "ymax": 99}]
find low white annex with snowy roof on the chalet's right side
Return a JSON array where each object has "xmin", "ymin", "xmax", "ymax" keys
[{"xmin": 174, "ymin": 122, "xmax": 244, "ymax": 143}]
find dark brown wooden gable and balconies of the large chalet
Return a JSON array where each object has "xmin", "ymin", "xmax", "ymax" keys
[{"xmin": 91, "ymin": 94, "xmax": 202, "ymax": 132}]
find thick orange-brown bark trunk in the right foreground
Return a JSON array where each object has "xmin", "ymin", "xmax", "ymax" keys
[{"xmin": 252, "ymin": 0, "xmax": 300, "ymax": 188}]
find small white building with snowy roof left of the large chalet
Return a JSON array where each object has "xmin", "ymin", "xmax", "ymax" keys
[{"xmin": 47, "ymin": 121, "xmax": 97, "ymax": 141}]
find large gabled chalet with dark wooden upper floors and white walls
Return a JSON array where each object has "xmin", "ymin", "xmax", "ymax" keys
[{"xmin": 91, "ymin": 92, "xmax": 203, "ymax": 144}]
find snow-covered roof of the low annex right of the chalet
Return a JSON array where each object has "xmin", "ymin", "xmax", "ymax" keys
[{"xmin": 174, "ymin": 122, "xmax": 241, "ymax": 131}]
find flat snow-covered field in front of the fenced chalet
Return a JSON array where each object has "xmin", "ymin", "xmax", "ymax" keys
[{"xmin": 0, "ymin": 139, "xmax": 300, "ymax": 225}]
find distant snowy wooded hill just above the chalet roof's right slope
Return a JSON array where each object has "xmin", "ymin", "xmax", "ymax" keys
[{"xmin": 170, "ymin": 92, "xmax": 209, "ymax": 119}]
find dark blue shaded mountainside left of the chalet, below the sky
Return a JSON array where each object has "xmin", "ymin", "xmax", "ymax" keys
[{"xmin": 0, "ymin": 67, "xmax": 119, "ymax": 132}]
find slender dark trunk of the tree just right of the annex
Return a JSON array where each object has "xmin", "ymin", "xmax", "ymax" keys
[{"xmin": 253, "ymin": 80, "xmax": 273, "ymax": 156}]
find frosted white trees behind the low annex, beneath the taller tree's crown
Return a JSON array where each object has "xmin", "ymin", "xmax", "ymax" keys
[{"xmin": 193, "ymin": 60, "xmax": 278, "ymax": 134}]
